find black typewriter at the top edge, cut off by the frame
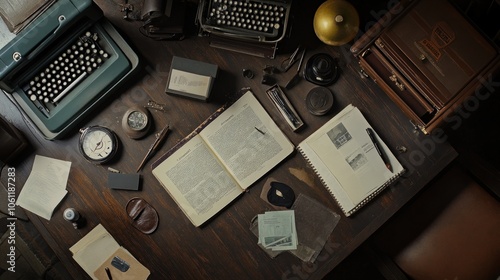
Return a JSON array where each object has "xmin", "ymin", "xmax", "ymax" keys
[{"xmin": 198, "ymin": 0, "xmax": 291, "ymax": 43}]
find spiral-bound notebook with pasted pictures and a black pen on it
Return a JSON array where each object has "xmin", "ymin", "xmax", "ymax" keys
[{"xmin": 297, "ymin": 105, "xmax": 405, "ymax": 216}]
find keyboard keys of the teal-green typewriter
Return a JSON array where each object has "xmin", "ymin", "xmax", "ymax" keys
[{"xmin": 23, "ymin": 31, "xmax": 109, "ymax": 116}]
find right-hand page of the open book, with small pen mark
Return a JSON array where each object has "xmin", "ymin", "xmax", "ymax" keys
[{"xmin": 200, "ymin": 91, "xmax": 294, "ymax": 189}]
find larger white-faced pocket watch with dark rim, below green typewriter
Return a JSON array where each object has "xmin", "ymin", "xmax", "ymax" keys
[{"xmin": 78, "ymin": 125, "xmax": 118, "ymax": 164}]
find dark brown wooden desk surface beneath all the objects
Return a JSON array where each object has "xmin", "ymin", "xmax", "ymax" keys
[{"xmin": 0, "ymin": 0, "xmax": 456, "ymax": 279}]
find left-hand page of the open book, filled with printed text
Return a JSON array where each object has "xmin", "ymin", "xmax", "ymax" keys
[{"xmin": 153, "ymin": 135, "xmax": 243, "ymax": 226}]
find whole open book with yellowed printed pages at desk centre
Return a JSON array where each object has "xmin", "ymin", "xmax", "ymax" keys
[{"xmin": 152, "ymin": 91, "xmax": 294, "ymax": 226}]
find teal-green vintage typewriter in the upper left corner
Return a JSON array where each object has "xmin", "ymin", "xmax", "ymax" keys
[{"xmin": 0, "ymin": 0, "xmax": 139, "ymax": 140}]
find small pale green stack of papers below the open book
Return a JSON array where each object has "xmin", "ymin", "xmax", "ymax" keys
[{"xmin": 258, "ymin": 210, "xmax": 298, "ymax": 251}]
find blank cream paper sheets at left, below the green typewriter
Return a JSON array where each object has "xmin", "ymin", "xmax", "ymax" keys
[{"xmin": 17, "ymin": 155, "xmax": 71, "ymax": 220}]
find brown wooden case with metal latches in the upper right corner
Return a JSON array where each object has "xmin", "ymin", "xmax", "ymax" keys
[{"xmin": 351, "ymin": 0, "xmax": 500, "ymax": 133}]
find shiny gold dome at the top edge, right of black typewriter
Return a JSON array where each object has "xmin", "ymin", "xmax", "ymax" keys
[{"xmin": 313, "ymin": 0, "xmax": 359, "ymax": 46}]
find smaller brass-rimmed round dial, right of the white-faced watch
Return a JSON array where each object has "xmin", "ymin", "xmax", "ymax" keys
[{"xmin": 122, "ymin": 106, "xmax": 151, "ymax": 139}]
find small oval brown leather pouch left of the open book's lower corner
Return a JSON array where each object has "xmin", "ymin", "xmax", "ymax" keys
[{"xmin": 126, "ymin": 197, "xmax": 159, "ymax": 234}]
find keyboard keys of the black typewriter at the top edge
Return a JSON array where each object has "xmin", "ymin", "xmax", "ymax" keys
[{"xmin": 206, "ymin": 0, "xmax": 287, "ymax": 37}]
